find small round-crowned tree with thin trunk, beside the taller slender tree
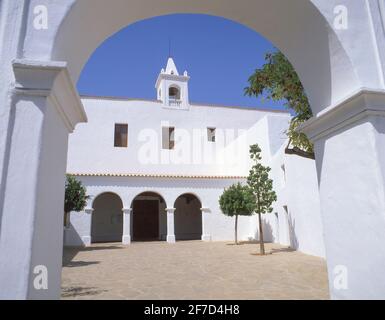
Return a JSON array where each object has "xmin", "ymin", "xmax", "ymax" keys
[{"xmin": 219, "ymin": 183, "xmax": 255, "ymax": 245}]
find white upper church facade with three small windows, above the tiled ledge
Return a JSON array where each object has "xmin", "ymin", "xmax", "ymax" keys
[{"xmin": 67, "ymin": 99, "xmax": 289, "ymax": 176}]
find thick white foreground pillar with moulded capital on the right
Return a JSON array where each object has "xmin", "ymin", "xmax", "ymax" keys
[{"xmin": 302, "ymin": 90, "xmax": 385, "ymax": 299}]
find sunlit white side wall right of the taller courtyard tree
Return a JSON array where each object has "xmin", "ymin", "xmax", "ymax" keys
[{"xmin": 264, "ymin": 118, "xmax": 325, "ymax": 257}]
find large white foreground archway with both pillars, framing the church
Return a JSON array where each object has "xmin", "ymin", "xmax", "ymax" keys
[{"xmin": 0, "ymin": 0, "xmax": 385, "ymax": 298}]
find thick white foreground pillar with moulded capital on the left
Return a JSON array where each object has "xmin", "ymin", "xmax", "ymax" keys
[{"xmin": 0, "ymin": 60, "xmax": 86, "ymax": 299}]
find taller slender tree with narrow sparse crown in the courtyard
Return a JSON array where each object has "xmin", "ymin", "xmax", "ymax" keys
[{"xmin": 247, "ymin": 144, "xmax": 277, "ymax": 255}]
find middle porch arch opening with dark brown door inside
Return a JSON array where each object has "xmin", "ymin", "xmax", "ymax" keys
[{"xmin": 131, "ymin": 192, "xmax": 167, "ymax": 241}]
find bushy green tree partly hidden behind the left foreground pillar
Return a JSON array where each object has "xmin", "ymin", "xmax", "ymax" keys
[{"xmin": 64, "ymin": 175, "xmax": 89, "ymax": 225}]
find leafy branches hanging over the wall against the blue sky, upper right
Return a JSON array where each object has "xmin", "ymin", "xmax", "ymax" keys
[{"xmin": 245, "ymin": 51, "xmax": 314, "ymax": 159}]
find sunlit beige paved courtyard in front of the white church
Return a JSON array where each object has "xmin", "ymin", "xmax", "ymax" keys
[{"xmin": 62, "ymin": 241, "xmax": 329, "ymax": 299}]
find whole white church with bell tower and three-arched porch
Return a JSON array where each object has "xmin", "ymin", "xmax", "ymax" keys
[{"xmin": 65, "ymin": 58, "xmax": 324, "ymax": 256}]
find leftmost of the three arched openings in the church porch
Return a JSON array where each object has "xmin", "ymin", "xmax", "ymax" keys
[{"xmin": 91, "ymin": 192, "xmax": 123, "ymax": 243}]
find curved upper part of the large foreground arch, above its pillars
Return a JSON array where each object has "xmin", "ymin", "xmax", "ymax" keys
[{"xmin": 38, "ymin": 0, "xmax": 360, "ymax": 113}]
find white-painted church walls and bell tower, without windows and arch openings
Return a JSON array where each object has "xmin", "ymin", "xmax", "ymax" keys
[{"xmin": 65, "ymin": 58, "xmax": 324, "ymax": 264}]
